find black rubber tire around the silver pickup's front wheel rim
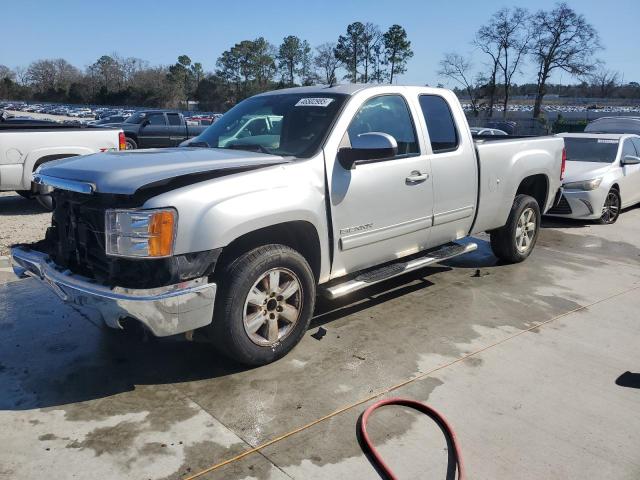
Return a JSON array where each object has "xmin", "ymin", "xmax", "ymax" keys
[{"xmin": 208, "ymin": 245, "xmax": 316, "ymax": 366}]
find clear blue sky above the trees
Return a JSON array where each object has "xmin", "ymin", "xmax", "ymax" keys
[{"xmin": 0, "ymin": 0, "xmax": 640, "ymax": 87}]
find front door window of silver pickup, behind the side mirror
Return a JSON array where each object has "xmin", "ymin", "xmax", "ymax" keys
[{"xmin": 347, "ymin": 95, "xmax": 419, "ymax": 155}]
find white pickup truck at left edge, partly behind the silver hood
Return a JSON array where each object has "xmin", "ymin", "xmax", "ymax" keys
[{"xmin": 0, "ymin": 121, "xmax": 125, "ymax": 209}]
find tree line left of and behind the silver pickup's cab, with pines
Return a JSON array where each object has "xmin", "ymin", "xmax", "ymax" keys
[{"xmin": 0, "ymin": 22, "xmax": 413, "ymax": 111}]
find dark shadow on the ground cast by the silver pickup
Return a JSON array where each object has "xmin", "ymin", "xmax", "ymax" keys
[{"xmin": 0, "ymin": 241, "xmax": 504, "ymax": 410}]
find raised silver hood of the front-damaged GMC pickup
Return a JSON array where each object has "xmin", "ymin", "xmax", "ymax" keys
[{"xmin": 37, "ymin": 147, "xmax": 289, "ymax": 195}]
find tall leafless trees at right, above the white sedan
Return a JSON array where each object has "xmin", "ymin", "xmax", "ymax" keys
[{"xmin": 439, "ymin": 3, "xmax": 640, "ymax": 117}]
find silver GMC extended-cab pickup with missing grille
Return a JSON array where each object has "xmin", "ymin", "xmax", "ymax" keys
[{"xmin": 12, "ymin": 85, "xmax": 564, "ymax": 365}]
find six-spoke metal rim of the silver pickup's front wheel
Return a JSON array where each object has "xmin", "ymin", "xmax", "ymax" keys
[{"xmin": 243, "ymin": 268, "xmax": 302, "ymax": 346}]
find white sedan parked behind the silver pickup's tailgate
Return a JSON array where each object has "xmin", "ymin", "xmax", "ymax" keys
[{"xmin": 547, "ymin": 133, "xmax": 640, "ymax": 224}]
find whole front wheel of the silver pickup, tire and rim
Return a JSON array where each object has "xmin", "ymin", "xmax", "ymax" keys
[{"xmin": 210, "ymin": 245, "xmax": 316, "ymax": 366}]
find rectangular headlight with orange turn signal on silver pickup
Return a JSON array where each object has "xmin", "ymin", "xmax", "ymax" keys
[{"xmin": 105, "ymin": 208, "xmax": 178, "ymax": 258}]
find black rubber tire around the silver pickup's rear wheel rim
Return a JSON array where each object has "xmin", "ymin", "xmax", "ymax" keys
[{"xmin": 490, "ymin": 195, "xmax": 541, "ymax": 263}]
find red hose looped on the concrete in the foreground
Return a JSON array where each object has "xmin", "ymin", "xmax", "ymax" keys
[{"xmin": 360, "ymin": 398, "xmax": 465, "ymax": 480}]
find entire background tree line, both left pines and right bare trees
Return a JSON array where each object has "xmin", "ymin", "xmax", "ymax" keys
[{"xmin": 0, "ymin": 3, "xmax": 640, "ymax": 117}]
